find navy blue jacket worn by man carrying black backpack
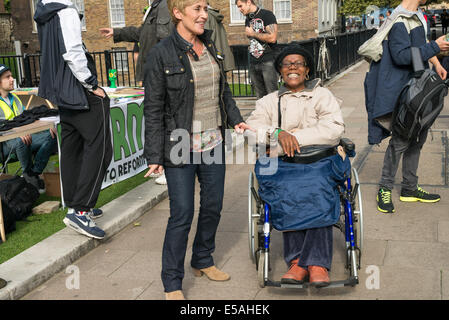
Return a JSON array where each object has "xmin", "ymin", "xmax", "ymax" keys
[{"xmin": 364, "ymin": 11, "xmax": 440, "ymax": 144}]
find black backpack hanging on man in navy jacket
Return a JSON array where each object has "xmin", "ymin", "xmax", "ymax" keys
[{"xmin": 391, "ymin": 48, "xmax": 449, "ymax": 141}]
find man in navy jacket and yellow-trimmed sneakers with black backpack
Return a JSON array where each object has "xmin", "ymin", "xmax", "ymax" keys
[{"xmin": 365, "ymin": 0, "xmax": 449, "ymax": 213}]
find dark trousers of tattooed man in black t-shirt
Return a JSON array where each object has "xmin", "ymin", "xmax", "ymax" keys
[{"xmin": 249, "ymin": 61, "xmax": 279, "ymax": 99}]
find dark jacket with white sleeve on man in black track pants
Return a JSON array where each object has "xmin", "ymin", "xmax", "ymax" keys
[{"xmin": 34, "ymin": 0, "xmax": 98, "ymax": 110}]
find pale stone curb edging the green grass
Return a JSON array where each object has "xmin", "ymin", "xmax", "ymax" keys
[{"xmin": 0, "ymin": 134, "xmax": 244, "ymax": 300}]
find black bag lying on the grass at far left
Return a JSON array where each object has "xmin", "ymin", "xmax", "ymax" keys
[{"xmin": 0, "ymin": 176, "xmax": 39, "ymax": 222}]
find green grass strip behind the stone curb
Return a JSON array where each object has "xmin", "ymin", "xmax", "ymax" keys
[{"xmin": 0, "ymin": 155, "xmax": 148, "ymax": 264}]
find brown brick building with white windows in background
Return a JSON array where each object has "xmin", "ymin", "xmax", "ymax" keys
[{"xmin": 11, "ymin": 0, "xmax": 340, "ymax": 53}]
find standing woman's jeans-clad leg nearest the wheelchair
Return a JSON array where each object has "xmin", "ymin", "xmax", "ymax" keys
[{"xmin": 191, "ymin": 144, "xmax": 226, "ymax": 269}]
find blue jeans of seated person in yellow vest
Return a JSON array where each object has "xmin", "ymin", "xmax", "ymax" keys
[{"xmin": 3, "ymin": 130, "xmax": 57, "ymax": 174}]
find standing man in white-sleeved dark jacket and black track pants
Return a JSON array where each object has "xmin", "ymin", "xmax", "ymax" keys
[{"xmin": 34, "ymin": 0, "xmax": 112, "ymax": 239}]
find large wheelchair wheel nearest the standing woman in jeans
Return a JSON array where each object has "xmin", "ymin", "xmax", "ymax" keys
[{"xmin": 248, "ymin": 171, "xmax": 259, "ymax": 264}]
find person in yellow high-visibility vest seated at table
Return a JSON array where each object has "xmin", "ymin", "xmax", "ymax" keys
[{"xmin": 0, "ymin": 64, "xmax": 56, "ymax": 193}]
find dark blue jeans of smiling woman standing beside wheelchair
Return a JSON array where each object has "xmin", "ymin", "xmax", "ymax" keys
[{"xmin": 161, "ymin": 144, "xmax": 226, "ymax": 292}]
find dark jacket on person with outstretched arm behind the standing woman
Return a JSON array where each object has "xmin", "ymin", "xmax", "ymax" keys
[{"xmin": 114, "ymin": 0, "xmax": 173, "ymax": 81}]
